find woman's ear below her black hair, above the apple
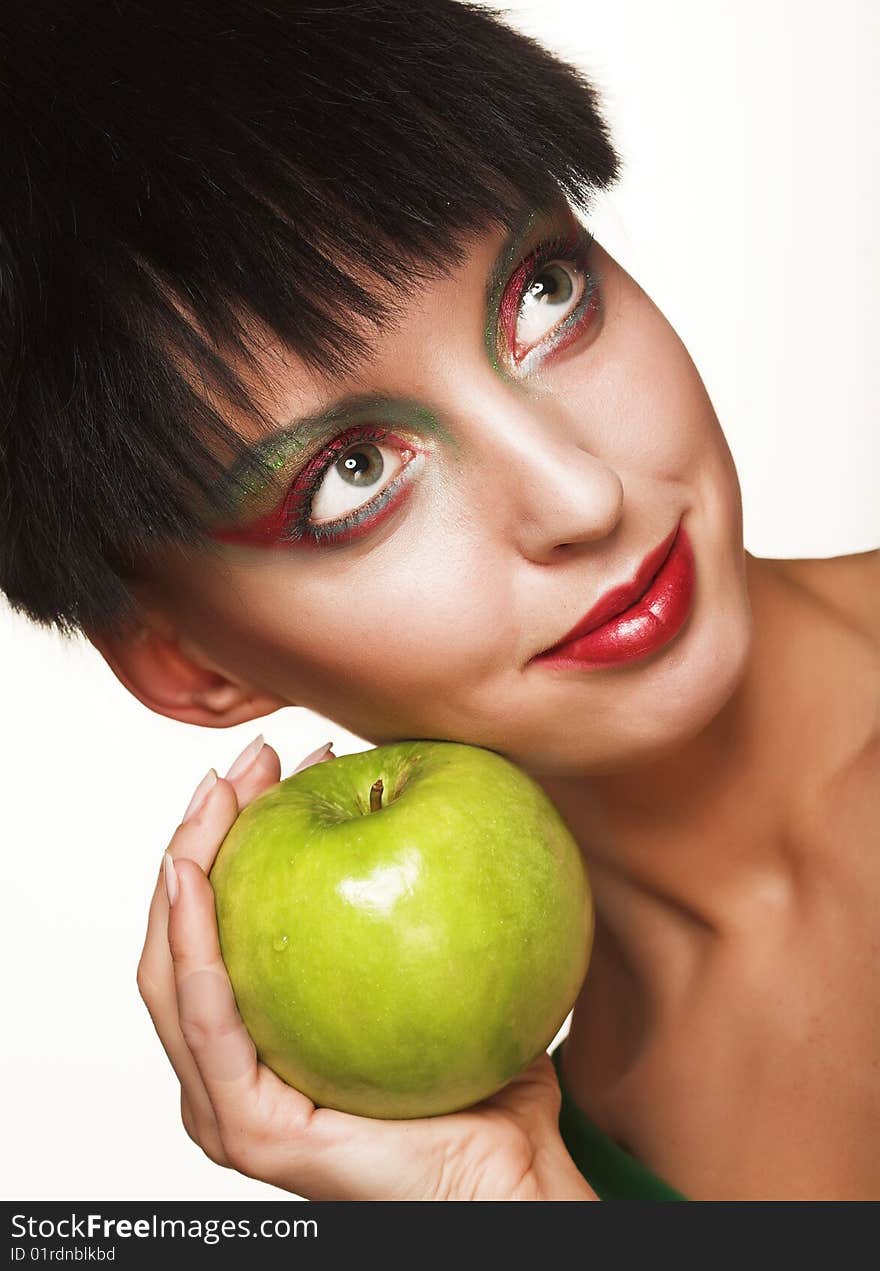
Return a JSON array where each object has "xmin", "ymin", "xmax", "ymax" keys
[{"xmin": 86, "ymin": 613, "xmax": 294, "ymax": 728}]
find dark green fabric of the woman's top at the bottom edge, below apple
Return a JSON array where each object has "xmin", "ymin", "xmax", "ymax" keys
[{"xmin": 551, "ymin": 1042, "xmax": 687, "ymax": 1200}]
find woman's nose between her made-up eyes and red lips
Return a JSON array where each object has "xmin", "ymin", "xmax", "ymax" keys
[{"xmin": 467, "ymin": 397, "xmax": 623, "ymax": 563}]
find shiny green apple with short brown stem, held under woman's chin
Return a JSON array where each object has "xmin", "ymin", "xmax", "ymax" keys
[{"xmin": 211, "ymin": 741, "xmax": 593, "ymax": 1117}]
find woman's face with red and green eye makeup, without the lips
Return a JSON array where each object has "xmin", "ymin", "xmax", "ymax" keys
[{"xmin": 142, "ymin": 200, "xmax": 750, "ymax": 775}]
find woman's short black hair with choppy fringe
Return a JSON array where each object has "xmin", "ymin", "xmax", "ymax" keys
[{"xmin": 0, "ymin": 0, "xmax": 619, "ymax": 634}]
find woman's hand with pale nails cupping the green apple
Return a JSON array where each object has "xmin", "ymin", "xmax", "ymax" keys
[{"xmin": 137, "ymin": 745, "xmax": 595, "ymax": 1200}]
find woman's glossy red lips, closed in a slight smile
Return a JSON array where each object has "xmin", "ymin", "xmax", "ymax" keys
[{"xmin": 534, "ymin": 524, "xmax": 696, "ymax": 669}]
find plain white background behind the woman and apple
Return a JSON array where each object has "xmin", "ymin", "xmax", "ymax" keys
[{"xmin": 0, "ymin": 0, "xmax": 880, "ymax": 1200}]
